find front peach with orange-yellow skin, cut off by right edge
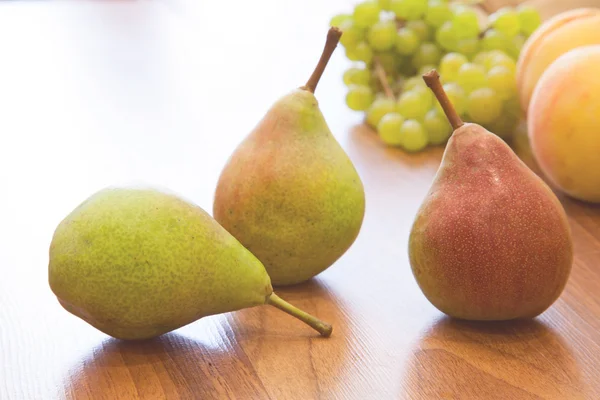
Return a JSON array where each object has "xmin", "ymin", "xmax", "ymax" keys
[{"xmin": 527, "ymin": 45, "xmax": 600, "ymax": 203}]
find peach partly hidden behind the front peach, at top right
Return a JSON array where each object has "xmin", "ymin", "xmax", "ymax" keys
[{"xmin": 517, "ymin": 8, "xmax": 600, "ymax": 112}]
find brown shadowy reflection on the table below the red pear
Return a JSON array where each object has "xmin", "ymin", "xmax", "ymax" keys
[{"xmin": 404, "ymin": 317, "xmax": 582, "ymax": 400}]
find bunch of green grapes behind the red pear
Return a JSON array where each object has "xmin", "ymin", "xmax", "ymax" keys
[{"xmin": 330, "ymin": 0, "xmax": 541, "ymax": 151}]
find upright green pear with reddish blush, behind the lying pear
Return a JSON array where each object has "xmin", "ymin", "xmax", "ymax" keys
[{"xmin": 213, "ymin": 28, "xmax": 365, "ymax": 285}]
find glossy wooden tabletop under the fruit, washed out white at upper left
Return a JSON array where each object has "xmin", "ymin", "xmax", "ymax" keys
[{"xmin": 0, "ymin": 0, "xmax": 600, "ymax": 400}]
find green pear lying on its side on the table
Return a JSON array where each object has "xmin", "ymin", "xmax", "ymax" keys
[{"xmin": 48, "ymin": 188, "xmax": 332, "ymax": 340}]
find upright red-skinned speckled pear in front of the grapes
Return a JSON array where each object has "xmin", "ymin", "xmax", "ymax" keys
[{"xmin": 409, "ymin": 70, "xmax": 573, "ymax": 320}]
